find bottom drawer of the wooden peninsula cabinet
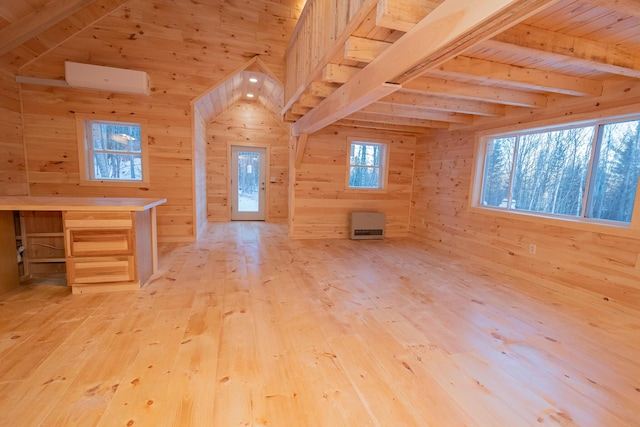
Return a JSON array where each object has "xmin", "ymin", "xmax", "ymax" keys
[{"xmin": 67, "ymin": 256, "xmax": 135, "ymax": 285}]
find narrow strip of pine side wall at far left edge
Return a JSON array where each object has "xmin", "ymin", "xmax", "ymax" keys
[{"xmin": 0, "ymin": 69, "xmax": 29, "ymax": 196}]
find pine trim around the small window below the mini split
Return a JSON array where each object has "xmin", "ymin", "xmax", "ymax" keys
[{"xmin": 75, "ymin": 113, "xmax": 150, "ymax": 188}]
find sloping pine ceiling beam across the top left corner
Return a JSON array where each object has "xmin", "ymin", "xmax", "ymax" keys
[{"xmin": 0, "ymin": 0, "xmax": 95, "ymax": 55}]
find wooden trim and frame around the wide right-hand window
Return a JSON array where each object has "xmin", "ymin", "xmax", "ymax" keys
[{"xmin": 469, "ymin": 113, "xmax": 640, "ymax": 237}]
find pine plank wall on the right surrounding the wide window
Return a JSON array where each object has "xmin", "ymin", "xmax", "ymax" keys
[{"xmin": 411, "ymin": 79, "xmax": 640, "ymax": 310}]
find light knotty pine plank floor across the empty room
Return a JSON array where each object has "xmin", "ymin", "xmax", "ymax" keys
[{"xmin": 0, "ymin": 223, "xmax": 640, "ymax": 427}]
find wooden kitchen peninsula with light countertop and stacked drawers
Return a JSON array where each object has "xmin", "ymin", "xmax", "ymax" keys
[{"xmin": 0, "ymin": 196, "xmax": 167, "ymax": 294}]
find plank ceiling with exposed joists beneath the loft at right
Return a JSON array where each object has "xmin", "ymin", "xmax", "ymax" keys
[{"xmin": 283, "ymin": 0, "xmax": 640, "ymax": 135}]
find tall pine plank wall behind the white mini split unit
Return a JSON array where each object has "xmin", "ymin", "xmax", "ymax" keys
[{"xmin": 15, "ymin": 0, "xmax": 301, "ymax": 241}]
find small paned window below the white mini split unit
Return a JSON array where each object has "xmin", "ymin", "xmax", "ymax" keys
[{"xmin": 78, "ymin": 118, "xmax": 148, "ymax": 183}]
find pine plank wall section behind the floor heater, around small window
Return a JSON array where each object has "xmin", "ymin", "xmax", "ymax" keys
[{"xmin": 290, "ymin": 126, "xmax": 416, "ymax": 238}]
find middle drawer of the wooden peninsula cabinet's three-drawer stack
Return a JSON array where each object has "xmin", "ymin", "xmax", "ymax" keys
[{"xmin": 68, "ymin": 229, "xmax": 133, "ymax": 257}]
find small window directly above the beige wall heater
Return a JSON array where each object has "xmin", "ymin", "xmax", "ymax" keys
[{"xmin": 349, "ymin": 140, "xmax": 387, "ymax": 189}]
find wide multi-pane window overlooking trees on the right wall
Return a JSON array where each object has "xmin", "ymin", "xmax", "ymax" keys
[{"xmin": 477, "ymin": 117, "xmax": 640, "ymax": 223}]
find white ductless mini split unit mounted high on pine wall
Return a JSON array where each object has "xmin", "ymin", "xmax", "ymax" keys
[{"xmin": 64, "ymin": 61, "xmax": 149, "ymax": 95}]
